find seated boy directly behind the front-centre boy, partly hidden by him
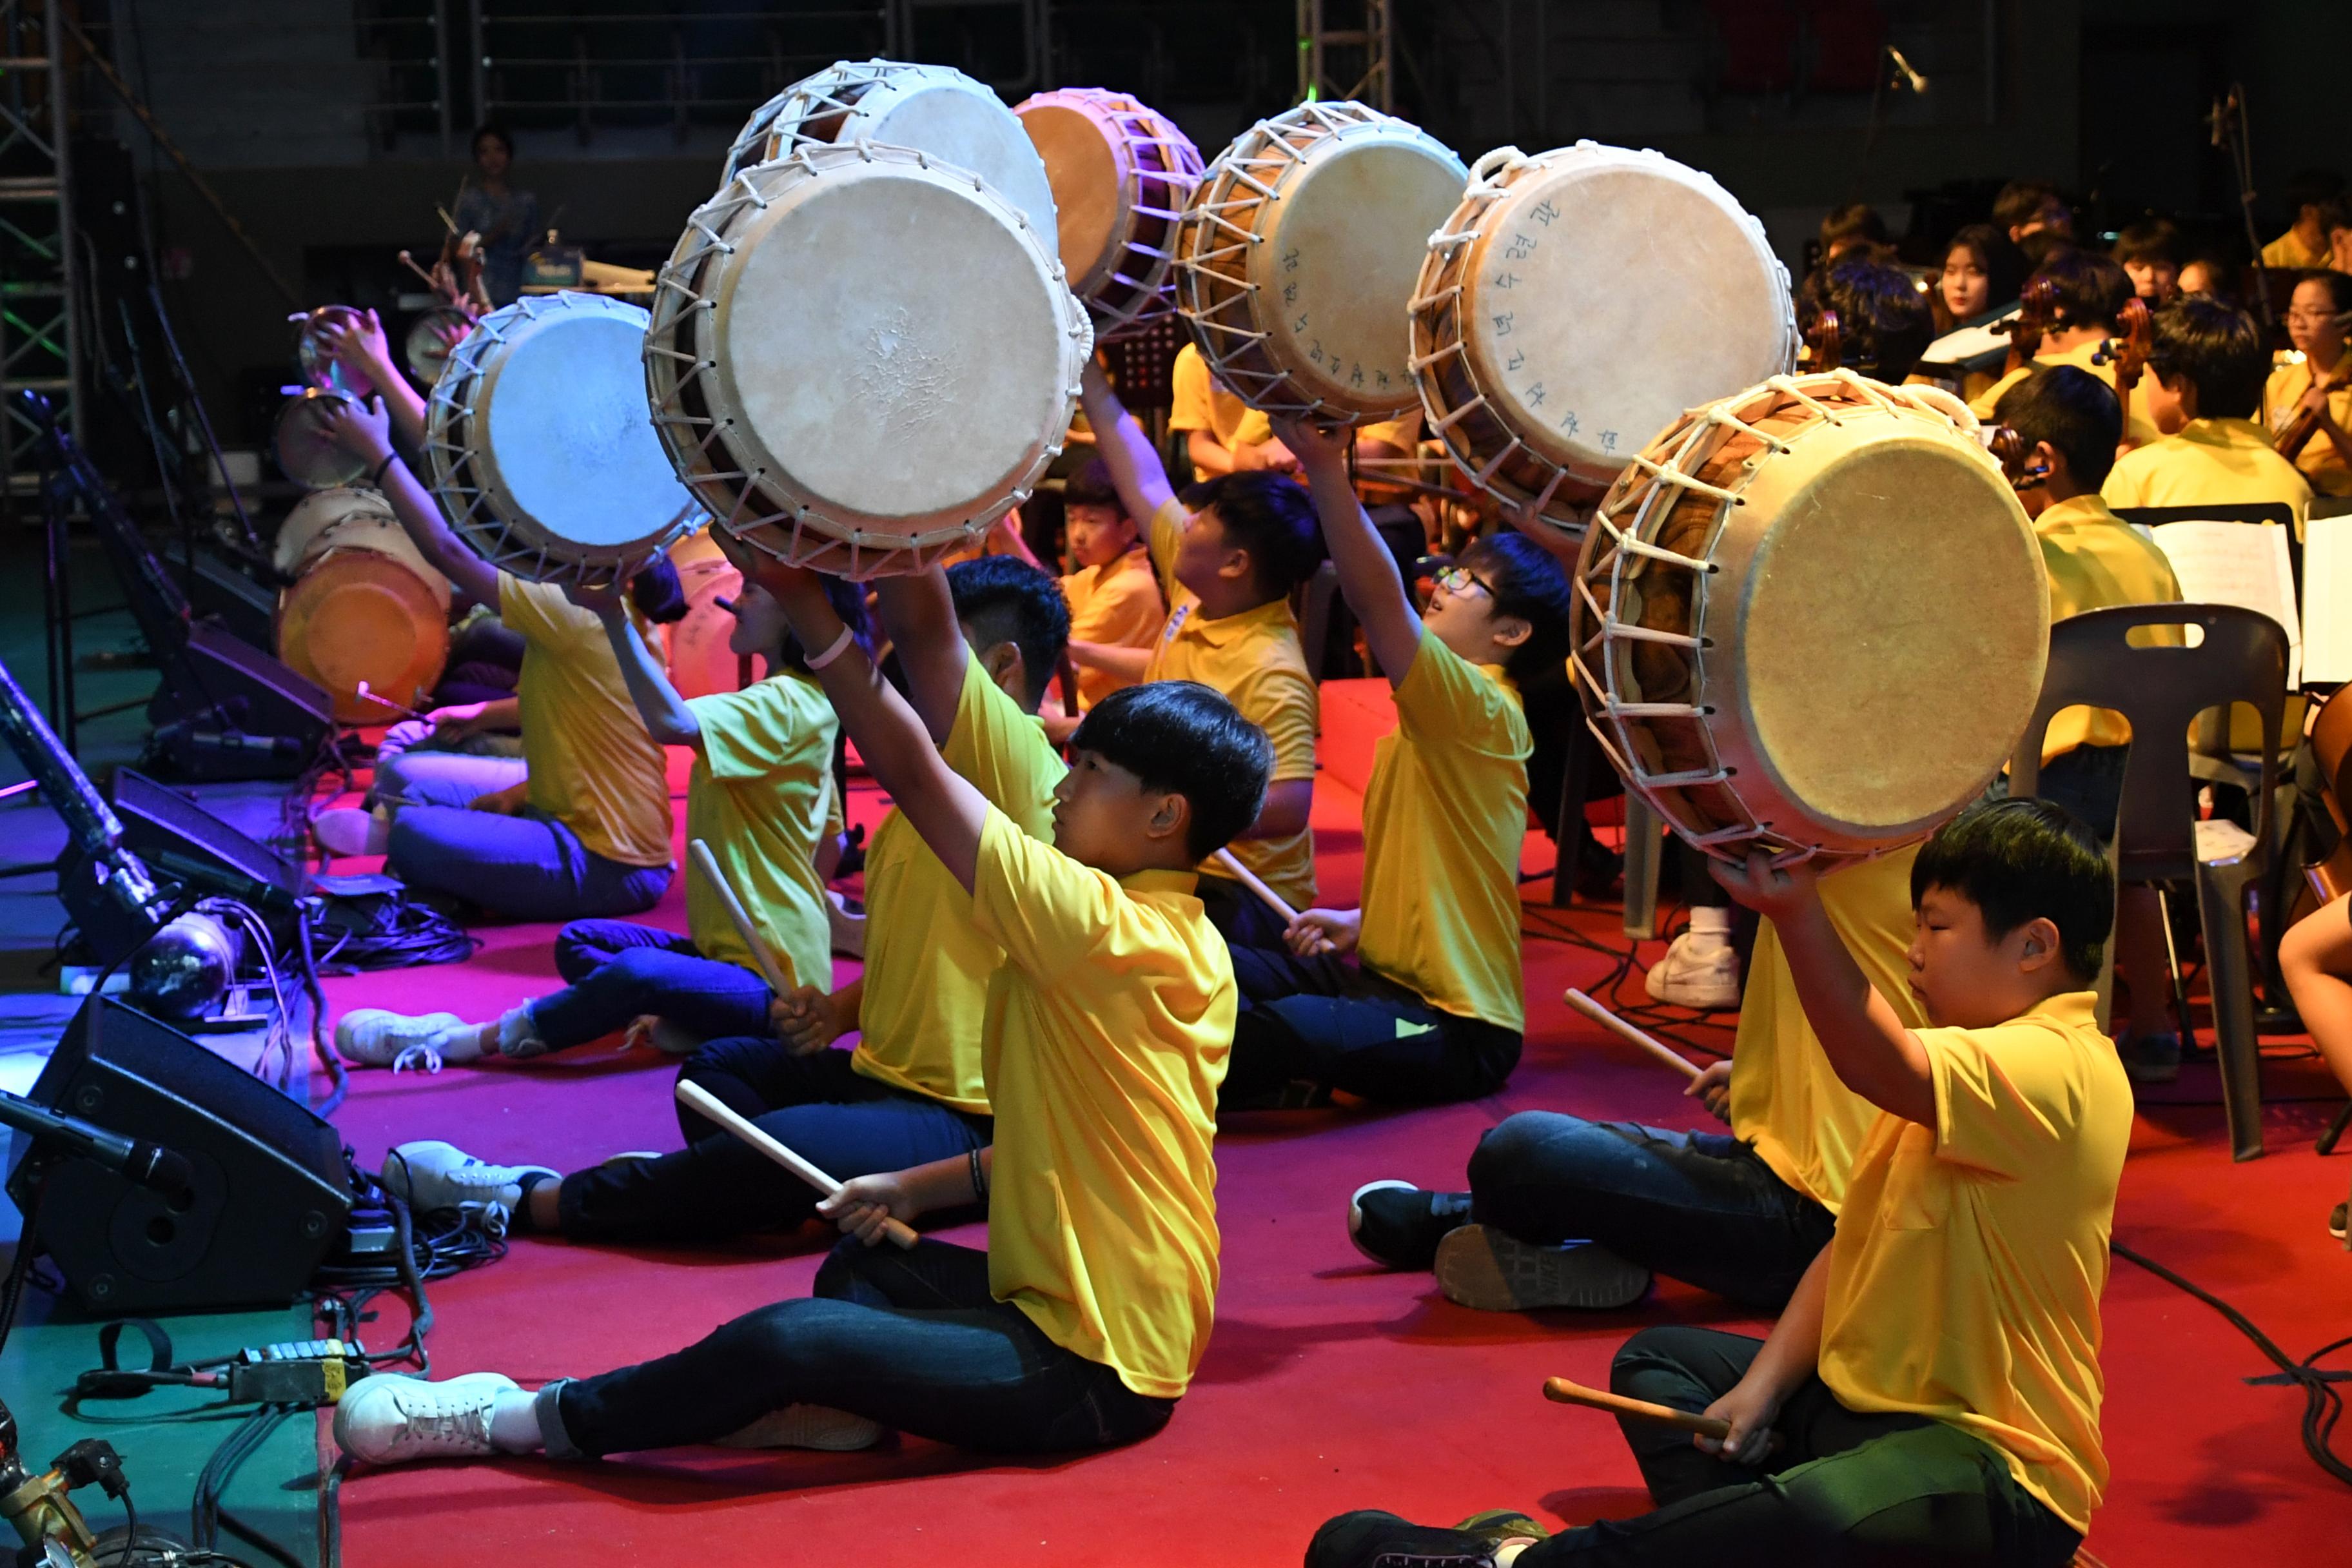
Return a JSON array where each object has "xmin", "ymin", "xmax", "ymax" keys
[{"xmin": 386, "ymin": 554, "xmax": 1068, "ymax": 1241}]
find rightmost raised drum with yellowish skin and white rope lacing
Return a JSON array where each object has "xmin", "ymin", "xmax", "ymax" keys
[{"xmin": 1576, "ymin": 371, "xmax": 2048, "ymax": 861}]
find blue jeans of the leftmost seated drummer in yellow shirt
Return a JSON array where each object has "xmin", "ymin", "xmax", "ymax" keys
[{"xmin": 384, "ymin": 776, "xmax": 671, "ymax": 919}]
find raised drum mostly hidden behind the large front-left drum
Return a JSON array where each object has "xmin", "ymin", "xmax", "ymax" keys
[{"xmin": 722, "ymin": 59, "xmax": 1054, "ymax": 235}]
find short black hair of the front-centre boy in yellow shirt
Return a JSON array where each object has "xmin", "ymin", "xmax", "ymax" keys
[{"xmin": 1070, "ymin": 681, "xmax": 1275, "ymax": 861}]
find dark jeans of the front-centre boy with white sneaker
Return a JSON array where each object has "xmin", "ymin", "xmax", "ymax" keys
[{"xmin": 538, "ymin": 1239, "xmax": 1176, "ymax": 1458}]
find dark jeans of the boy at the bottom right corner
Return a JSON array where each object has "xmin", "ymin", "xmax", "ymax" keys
[{"xmin": 1520, "ymin": 1326, "xmax": 2081, "ymax": 1568}]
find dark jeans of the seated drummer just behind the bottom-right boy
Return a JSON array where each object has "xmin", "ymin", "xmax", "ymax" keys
[{"xmin": 1470, "ymin": 1110, "xmax": 1837, "ymax": 1312}]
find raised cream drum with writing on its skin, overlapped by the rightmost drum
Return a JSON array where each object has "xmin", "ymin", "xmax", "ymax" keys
[{"xmin": 1411, "ymin": 141, "xmax": 1797, "ymax": 534}]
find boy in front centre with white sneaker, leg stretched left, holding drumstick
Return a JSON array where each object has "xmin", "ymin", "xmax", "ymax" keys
[{"xmin": 334, "ymin": 564, "xmax": 1273, "ymax": 1465}]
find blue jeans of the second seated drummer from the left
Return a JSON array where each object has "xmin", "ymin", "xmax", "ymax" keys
[{"xmin": 531, "ymin": 919, "xmax": 772, "ymax": 1051}]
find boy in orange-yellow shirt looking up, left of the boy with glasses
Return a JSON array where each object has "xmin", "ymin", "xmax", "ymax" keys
[{"xmin": 1072, "ymin": 362, "xmax": 1320, "ymax": 947}]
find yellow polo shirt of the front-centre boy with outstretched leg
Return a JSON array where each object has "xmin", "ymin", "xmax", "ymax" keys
[{"xmin": 972, "ymin": 808, "xmax": 1237, "ymax": 1398}]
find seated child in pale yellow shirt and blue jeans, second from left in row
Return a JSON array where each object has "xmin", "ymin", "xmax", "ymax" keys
[{"xmin": 334, "ymin": 545, "xmax": 865, "ymax": 1072}]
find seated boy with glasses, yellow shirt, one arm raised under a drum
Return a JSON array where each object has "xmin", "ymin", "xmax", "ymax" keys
[{"xmin": 1226, "ymin": 423, "xmax": 1569, "ymax": 1110}]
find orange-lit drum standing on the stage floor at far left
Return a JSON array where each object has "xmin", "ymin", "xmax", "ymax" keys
[{"xmin": 271, "ymin": 489, "xmax": 449, "ymax": 724}]
